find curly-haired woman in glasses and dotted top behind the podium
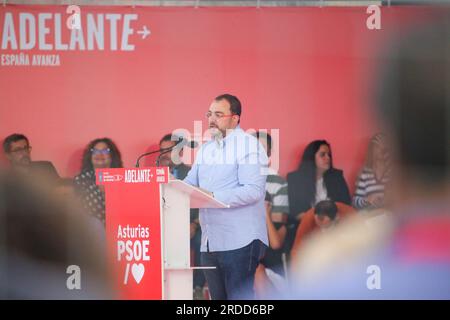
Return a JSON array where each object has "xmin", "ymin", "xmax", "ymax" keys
[{"xmin": 75, "ymin": 138, "xmax": 123, "ymax": 225}]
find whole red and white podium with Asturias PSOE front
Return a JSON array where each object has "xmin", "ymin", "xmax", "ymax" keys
[{"xmin": 96, "ymin": 167, "xmax": 227, "ymax": 300}]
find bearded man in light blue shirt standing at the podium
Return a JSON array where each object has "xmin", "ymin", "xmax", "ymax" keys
[{"xmin": 184, "ymin": 94, "xmax": 268, "ymax": 300}]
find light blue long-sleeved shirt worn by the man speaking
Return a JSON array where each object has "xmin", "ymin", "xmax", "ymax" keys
[{"xmin": 184, "ymin": 126, "xmax": 269, "ymax": 252}]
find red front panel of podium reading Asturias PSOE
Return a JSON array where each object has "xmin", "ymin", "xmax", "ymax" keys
[{"xmin": 96, "ymin": 167, "xmax": 168, "ymax": 300}]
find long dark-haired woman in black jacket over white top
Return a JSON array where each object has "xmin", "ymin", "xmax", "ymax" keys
[{"xmin": 286, "ymin": 140, "xmax": 351, "ymax": 255}]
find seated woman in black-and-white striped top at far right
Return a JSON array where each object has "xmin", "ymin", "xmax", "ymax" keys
[{"xmin": 353, "ymin": 133, "xmax": 390, "ymax": 210}]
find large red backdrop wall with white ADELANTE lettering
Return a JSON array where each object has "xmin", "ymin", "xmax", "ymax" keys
[{"xmin": 0, "ymin": 5, "xmax": 440, "ymax": 188}]
